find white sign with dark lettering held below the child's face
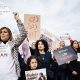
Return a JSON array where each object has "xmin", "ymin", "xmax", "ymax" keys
[{"xmin": 25, "ymin": 68, "xmax": 47, "ymax": 80}]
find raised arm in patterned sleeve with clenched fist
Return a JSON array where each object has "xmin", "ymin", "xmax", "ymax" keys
[{"xmin": 13, "ymin": 13, "xmax": 27, "ymax": 46}]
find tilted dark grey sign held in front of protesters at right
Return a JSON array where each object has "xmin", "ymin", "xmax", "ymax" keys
[{"xmin": 53, "ymin": 46, "xmax": 77, "ymax": 65}]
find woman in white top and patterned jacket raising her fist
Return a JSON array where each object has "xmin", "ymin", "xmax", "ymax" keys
[{"xmin": 0, "ymin": 13, "xmax": 26, "ymax": 80}]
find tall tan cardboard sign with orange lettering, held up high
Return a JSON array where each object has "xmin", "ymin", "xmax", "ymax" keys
[{"xmin": 24, "ymin": 14, "xmax": 40, "ymax": 42}]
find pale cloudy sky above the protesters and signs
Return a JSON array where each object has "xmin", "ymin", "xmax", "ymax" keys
[{"xmin": 0, "ymin": 0, "xmax": 80, "ymax": 41}]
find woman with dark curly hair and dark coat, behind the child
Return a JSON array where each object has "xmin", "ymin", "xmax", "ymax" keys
[{"xmin": 34, "ymin": 39, "xmax": 56, "ymax": 80}]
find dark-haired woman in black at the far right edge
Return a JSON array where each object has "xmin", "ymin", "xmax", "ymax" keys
[{"xmin": 70, "ymin": 40, "xmax": 80, "ymax": 80}]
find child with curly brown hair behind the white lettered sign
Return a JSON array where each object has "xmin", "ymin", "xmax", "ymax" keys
[{"xmin": 20, "ymin": 56, "xmax": 39, "ymax": 80}]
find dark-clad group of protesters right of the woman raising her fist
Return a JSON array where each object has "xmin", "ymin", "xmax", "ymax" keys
[{"xmin": 19, "ymin": 39, "xmax": 80, "ymax": 80}]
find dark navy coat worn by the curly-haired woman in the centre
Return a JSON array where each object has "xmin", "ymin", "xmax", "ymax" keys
[{"xmin": 34, "ymin": 50, "xmax": 57, "ymax": 80}]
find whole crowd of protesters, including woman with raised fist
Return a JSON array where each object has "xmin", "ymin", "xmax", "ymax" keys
[{"xmin": 0, "ymin": 13, "xmax": 80, "ymax": 80}]
